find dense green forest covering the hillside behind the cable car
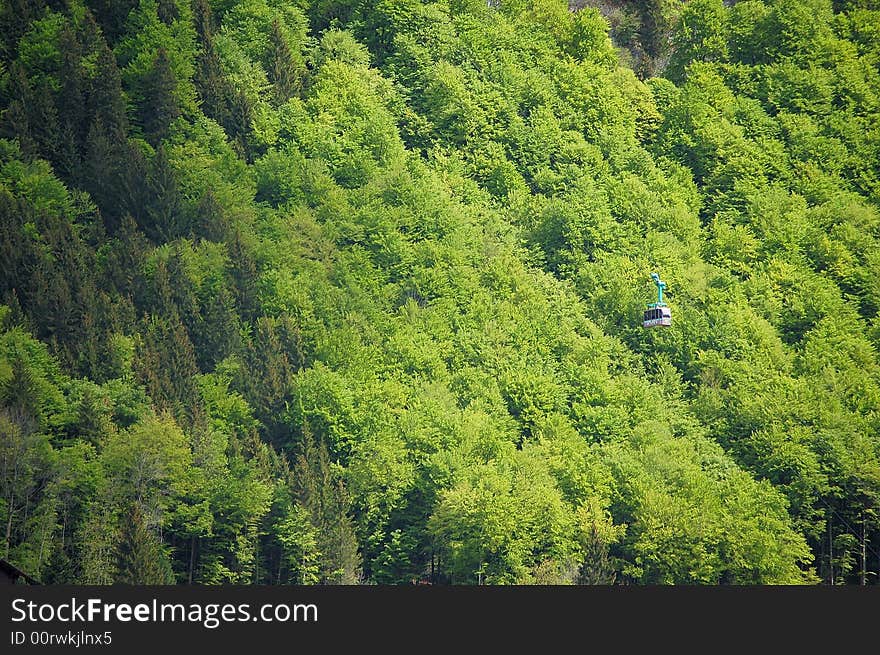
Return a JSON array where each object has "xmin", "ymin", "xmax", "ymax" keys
[{"xmin": 0, "ymin": 0, "xmax": 880, "ymax": 584}]
